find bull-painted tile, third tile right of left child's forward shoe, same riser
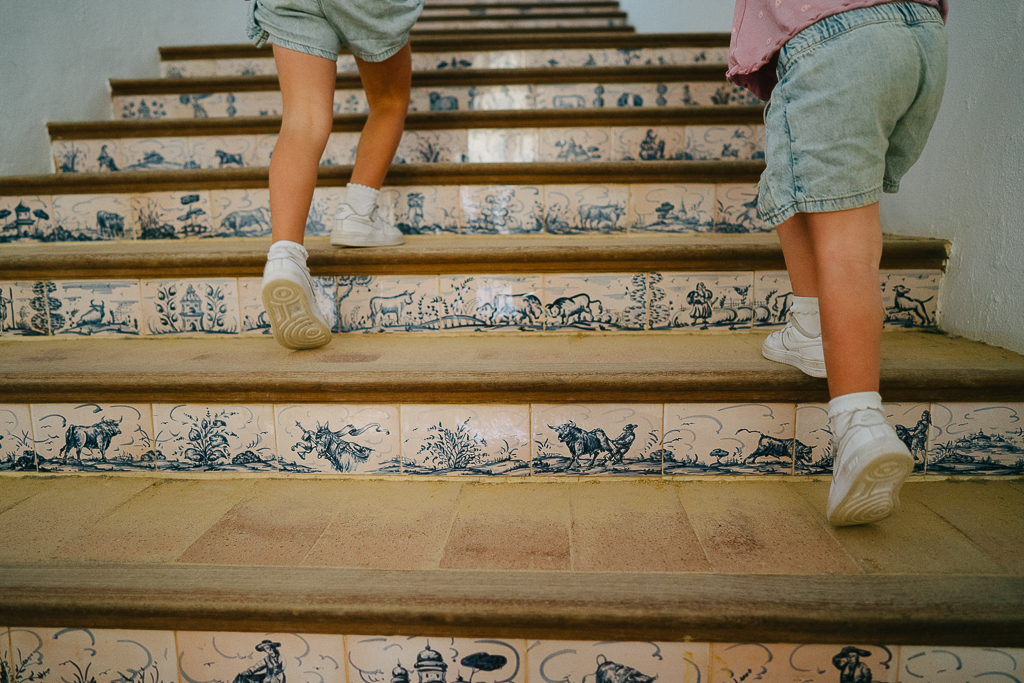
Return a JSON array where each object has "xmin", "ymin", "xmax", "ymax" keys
[{"xmin": 544, "ymin": 185, "xmax": 630, "ymax": 234}]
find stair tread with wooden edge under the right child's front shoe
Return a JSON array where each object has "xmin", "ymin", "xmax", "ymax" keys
[{"xmin": 0, "ymin": 332, "xmax": 1024, "ymax": 403}]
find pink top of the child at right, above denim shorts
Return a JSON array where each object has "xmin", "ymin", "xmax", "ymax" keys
[{"xmin": 726, "ymin": 0, "xmax": 949, "ymax": 99}]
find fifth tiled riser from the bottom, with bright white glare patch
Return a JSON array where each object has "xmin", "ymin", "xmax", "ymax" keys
[{"xmin": 52, "ymin": 125, "xmax": 764, "ymax": 173}]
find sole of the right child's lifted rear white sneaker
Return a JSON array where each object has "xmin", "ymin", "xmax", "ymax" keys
[{"xmin": 828, "ymin": 453, "xmax": 913, "ymax": 526}]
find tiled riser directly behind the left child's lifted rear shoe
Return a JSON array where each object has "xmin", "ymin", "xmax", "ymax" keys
[{"xmin": 0, "ymin": 270, "xmax": 941, "ymax": 338}]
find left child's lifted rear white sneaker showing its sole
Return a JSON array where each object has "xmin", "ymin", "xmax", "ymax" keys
[{"xmin": 262, "ymin": 247, "xmax": 331, "ymax": 349}]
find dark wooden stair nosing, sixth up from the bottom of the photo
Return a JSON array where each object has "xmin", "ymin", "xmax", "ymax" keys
[{"xmin": 111, "ymin": 63, "xmax": 726, "ymax": 97}]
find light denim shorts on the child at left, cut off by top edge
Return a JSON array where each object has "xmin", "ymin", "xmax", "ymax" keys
[{"xmin": 249, "ymin": 0, "xmax": 423, "ymax": 61}]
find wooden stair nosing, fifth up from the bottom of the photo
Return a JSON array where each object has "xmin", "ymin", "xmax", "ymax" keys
[{"xmin": 46, "ymin": 104, "xmax": 764, "ymax": 140}]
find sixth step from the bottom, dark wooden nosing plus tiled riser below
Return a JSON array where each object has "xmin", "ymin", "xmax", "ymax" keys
[{"xmin": 111, "ymin": 65, "xmax": 761, "ymax": 119}]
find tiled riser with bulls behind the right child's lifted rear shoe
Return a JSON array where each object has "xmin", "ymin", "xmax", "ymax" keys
[{"xmin": 0, "ymin": 395, "xmax": 1024, "ymax": 479}]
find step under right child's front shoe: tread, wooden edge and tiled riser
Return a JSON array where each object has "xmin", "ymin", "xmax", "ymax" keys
[{"xmin": 0, "ymin": 331, "xmax": 1024, "ymax": 475}]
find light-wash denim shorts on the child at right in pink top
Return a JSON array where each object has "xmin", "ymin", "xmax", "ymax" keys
[{"xmin": 758, "ymin": 2, "xmax": 946, "ymax": 228}]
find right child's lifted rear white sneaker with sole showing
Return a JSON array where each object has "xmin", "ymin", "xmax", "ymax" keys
[{"xmin": 827, "ymin": 392, "xmax": 913, "ymax": 526}]
